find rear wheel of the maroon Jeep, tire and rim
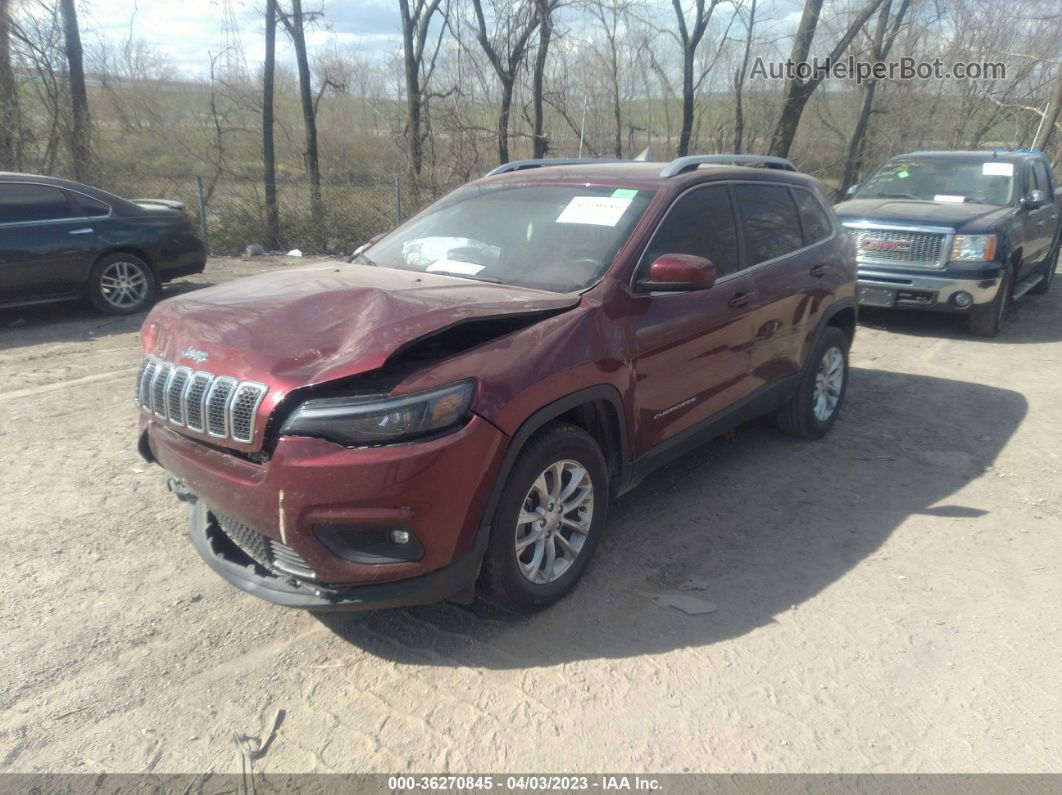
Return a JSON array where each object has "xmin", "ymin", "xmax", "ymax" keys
[{"xmin": 774, "ymin": 326, "xmax": 849, "ymax": 439}]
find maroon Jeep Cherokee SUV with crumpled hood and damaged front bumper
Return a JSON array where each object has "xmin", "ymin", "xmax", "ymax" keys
[{"xmin": 136, "ymin": 156, "xmax": 856, "ymax": 609}]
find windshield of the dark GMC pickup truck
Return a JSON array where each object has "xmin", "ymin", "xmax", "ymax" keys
[{"xmin": 855, "ymin": 158, "xmax": 1014, "ymax": 207}]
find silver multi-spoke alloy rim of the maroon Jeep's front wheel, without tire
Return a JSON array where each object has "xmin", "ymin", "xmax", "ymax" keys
[{"xmin": 516, "ymin": 460, "xmax": 594, "ymax": 585}]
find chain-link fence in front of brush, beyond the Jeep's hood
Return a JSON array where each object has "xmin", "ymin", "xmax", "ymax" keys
[{"xmin": 103, "ymin": 174, "xmax": 434, "ymax": 255}]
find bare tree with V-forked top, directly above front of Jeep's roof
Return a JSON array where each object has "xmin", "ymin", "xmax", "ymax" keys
[{"xmin": 472, "ymin": 0, "xmax": 539, "ymax": 162}]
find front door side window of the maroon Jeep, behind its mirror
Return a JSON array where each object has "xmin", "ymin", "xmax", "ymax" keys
[{"xmin": 641, "ymin": 185, "xmax": 740, "ymax": 276}]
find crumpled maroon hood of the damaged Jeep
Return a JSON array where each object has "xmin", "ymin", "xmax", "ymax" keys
[{"xmin": 143, "ymin": 262, "xmax": 580, "ymax": 397}]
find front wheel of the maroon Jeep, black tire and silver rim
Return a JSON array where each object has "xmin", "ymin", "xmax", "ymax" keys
[{"xmin": 481, "ymin": 422, "xmax": 609, "ymax": 611}]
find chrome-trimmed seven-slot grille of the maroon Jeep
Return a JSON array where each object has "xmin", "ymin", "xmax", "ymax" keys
[{"xmin": 135, "ymin": 356, "xmax": 269, "ymax": 444}]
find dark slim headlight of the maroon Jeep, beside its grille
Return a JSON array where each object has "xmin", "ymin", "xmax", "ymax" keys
[{"xmin": 280, "ymin": 381, "xmax": 475, "ymax": 447}]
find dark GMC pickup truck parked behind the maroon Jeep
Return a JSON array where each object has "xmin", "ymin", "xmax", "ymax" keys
[{"xmin": 835, "ymin": 150, "xmax": 1062, "ymax": 336}]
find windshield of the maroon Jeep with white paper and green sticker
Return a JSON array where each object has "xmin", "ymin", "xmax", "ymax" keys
[{"xmin": 355, "ymin": 185, "xmax": 653, "ymax": 293}]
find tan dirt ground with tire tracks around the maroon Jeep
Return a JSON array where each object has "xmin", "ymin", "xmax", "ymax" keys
[{"xmin": 0, "ymin": 259, "xmax": 1062, "ymax": 773}]
